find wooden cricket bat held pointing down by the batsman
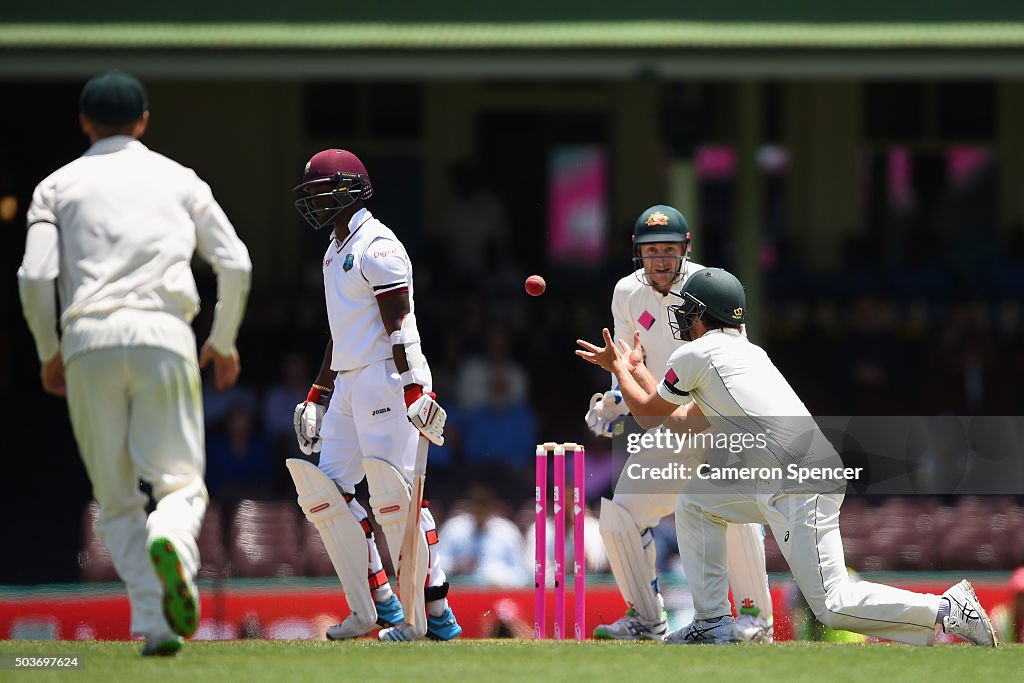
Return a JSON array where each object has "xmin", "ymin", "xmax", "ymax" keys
[{"xmin": 398, "ymin": 436, "xmax": 430, "ymax": 636}]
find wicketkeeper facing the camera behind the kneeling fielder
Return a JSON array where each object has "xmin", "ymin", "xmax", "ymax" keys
[{"xmin": 586, "ymin": 205, "xmax": 773, "ymax": 642}]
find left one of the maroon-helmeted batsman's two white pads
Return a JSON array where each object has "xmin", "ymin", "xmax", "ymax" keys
[{"xmin": 285, "ymin": 458, "xmax": 377, "ymax": 622}]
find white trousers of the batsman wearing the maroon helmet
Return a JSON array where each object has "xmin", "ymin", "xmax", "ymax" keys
[{"xmin": 319, "ymin": 359, "xmax": 445, "ymax": 586}]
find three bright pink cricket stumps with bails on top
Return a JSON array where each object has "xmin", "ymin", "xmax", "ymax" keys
[{"xmin": 534, "ymin": 441, "xmax": 587, "ymax": 640}]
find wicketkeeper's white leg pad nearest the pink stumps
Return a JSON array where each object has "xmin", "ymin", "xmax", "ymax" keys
[{"xmin": 599, "ymin": 498, "xmax": 662, "ymax": 622}]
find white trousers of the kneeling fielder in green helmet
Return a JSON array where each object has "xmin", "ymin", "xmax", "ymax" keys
[{"xmin": 676, "ymin": 481, "xmax": 939, "ymax": 645}]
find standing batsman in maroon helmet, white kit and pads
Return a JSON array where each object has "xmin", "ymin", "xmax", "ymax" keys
[{"xmin": 287, "ymin": 150, "xmax": 462, "ymax": 641}]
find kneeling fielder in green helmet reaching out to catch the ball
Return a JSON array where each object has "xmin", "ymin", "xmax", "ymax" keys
[{"xmin": 577, "ymin": 268, "xmax": 997, "ymax": 647}]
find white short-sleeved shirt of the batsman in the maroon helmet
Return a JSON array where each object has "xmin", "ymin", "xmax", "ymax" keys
[{"xmin": 324, "ymin": 209, "xmax": 415, "ymax": 372}]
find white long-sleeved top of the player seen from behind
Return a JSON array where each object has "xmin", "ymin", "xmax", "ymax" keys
[{"xmin": 17, "ymin": 135, "xmax": 252, "ymax": 361}]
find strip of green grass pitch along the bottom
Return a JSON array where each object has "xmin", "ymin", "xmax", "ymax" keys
[{"xmin": 0, "ymin": 640, "xmax": 1024, "ymax": 683}]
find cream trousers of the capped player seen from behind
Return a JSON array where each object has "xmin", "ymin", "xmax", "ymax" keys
[{"xmin": 66, "ymin": 344, "xmax": 209, "ymax": 634}]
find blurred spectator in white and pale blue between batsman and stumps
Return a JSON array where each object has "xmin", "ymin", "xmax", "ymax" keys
[{"xmin": 438, "ymin": 483, "xmax": 532, "ymax": 588}]
